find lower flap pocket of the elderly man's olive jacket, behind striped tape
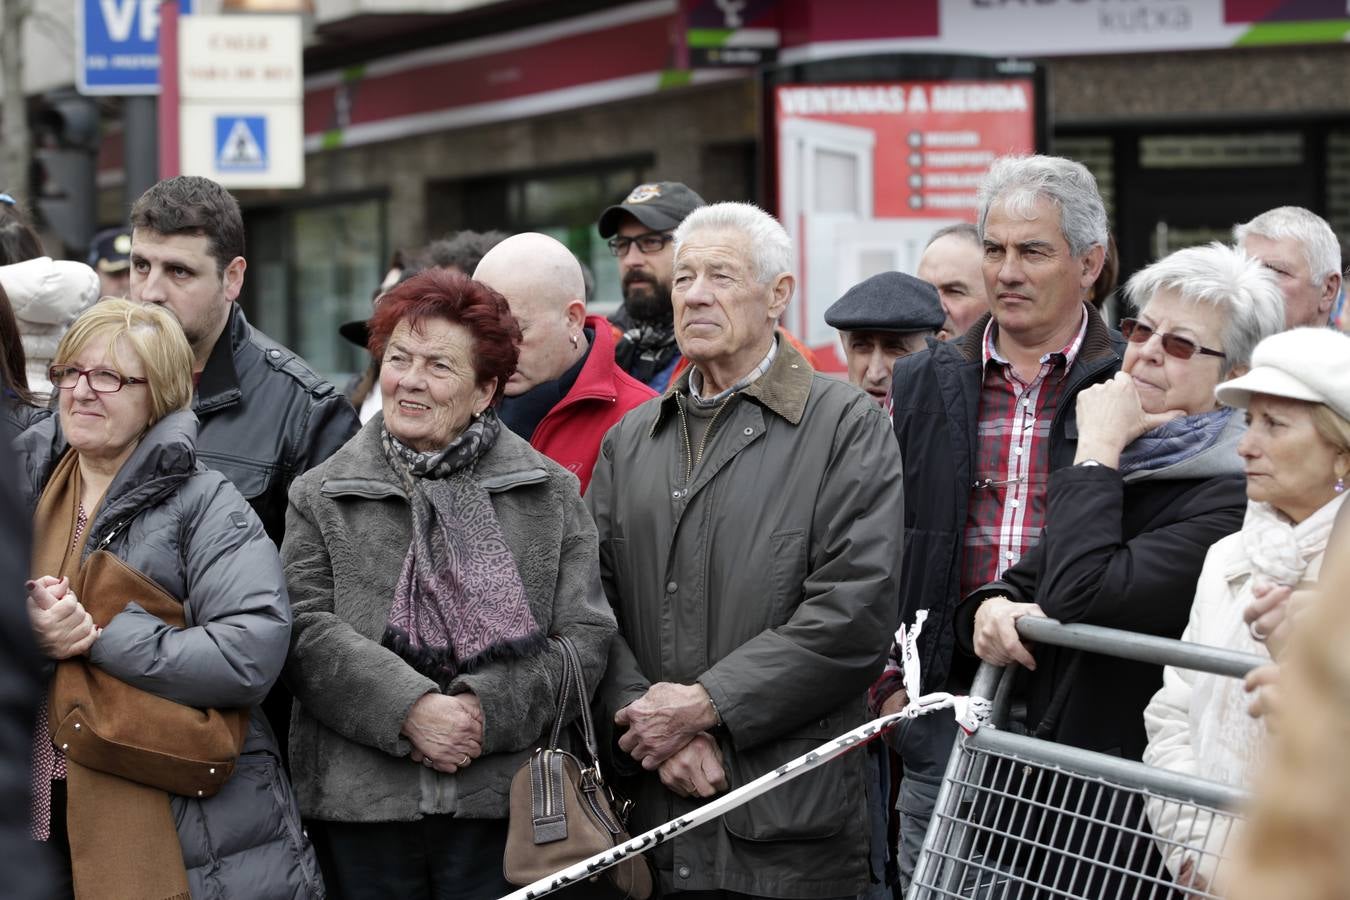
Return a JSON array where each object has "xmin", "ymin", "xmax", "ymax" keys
[{"xmin": 722, "ymin": 719, "xmax": 860, "ymax": 841}]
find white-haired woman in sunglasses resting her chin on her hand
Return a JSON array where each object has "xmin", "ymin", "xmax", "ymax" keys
[{"xmin": 957, "ymin": 243, "xmax": 1284, "ymax": 896}]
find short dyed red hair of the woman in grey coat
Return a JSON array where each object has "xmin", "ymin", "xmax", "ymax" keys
[{"xmin": 369, "ymin": 269, "xmax": 521, "ymax": 405}]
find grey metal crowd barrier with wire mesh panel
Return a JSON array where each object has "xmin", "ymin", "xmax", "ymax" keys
[{"xmin": 907, "ymin": 617, "xmax": 1268, "ymax": 900}]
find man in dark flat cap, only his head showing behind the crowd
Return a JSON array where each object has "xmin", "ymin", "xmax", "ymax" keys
[{"xmin": 825, "ymin": 271, "xmax": 946, "ymax": 406}]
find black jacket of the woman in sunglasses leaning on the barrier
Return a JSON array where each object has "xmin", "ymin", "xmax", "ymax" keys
[{"xmin": 956, "ymin": 416, "xmax": 1247, "ymax": 760}]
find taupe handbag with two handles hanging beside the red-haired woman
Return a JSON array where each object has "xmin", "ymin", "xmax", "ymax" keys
[{"xmin": 502, "ymin": 636, "xmax": 652, "ymax": 900}]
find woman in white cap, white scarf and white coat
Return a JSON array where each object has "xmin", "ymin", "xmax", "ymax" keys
[{"xmin": 1143, "ymin": 328, "xmax": 1350, "ymax": 885}]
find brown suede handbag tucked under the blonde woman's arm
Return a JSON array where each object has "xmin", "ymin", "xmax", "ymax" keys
[{"xmin": 50, "ymin": 551, "xmax": 248, "ymax": 797}]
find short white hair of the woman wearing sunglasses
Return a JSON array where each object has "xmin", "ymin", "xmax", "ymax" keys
[{"xmin": 1125, "ymin": 242, "xmax": 1284, "ymax": 375}]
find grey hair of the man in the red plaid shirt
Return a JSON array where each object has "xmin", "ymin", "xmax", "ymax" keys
[{"xmin": 979, "ymin": 157, "xmax": 1107, "ymax": 256}]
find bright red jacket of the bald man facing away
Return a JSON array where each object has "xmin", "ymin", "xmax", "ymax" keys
[{"xmin": 529, "ymin": 316, "xmax": 656, "ymax": 494}]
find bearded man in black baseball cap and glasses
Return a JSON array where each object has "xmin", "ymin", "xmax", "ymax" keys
[{"xmin": 598, "ymin": 181, "xmax": 705, "ymax": 393}]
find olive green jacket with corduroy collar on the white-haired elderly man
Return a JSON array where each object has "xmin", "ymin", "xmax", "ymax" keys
[{"xmin": 587, "ymin": 343, "xmax": 903, "ymax": 897}]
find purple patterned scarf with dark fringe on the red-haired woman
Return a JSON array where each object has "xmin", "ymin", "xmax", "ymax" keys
[{"xmin": 381, "ymin": 410, "xmax": 548, "ymax": 690}]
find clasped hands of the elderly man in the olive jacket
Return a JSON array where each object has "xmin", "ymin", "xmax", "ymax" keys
[{"xmin": 614, "ymin": 681, "xmax": 728, "ymax": 797}]
